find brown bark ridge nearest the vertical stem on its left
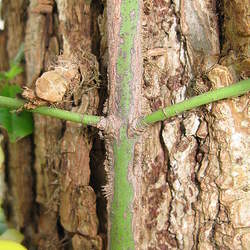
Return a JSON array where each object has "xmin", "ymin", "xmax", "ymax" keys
[{"xmin": 56, "ymin": 0, "xmax": 102, "ymax": 250}]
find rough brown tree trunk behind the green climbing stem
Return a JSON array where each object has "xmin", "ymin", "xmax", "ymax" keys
[{"xmin": 0, "ymin": 0, "xmax": 250, "ymax": 250}]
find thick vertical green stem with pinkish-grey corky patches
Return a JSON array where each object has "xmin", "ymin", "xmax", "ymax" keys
[{"xmin": 107, "ymin": 0, "xmax": 142, "ymax": 250}]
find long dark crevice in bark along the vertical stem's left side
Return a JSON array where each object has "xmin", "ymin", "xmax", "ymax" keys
[{"xmin": 90, "ymin": 0, "xmax": 108, "ymax": 249}]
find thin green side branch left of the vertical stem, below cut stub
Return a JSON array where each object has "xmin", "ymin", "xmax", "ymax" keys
[{"xmin": 0, "ymin": 96, "xmax": 101, "ymax": 125}]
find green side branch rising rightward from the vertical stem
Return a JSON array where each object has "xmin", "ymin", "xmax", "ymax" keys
[{"xmin": 140, "ymin": 79, "xmax": 250, "ymax": 125}]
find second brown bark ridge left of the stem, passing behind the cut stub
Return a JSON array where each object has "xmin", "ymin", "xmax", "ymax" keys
[{"xmin": 25, "ymin": 0, "xmax": 62, "ymax": 249}]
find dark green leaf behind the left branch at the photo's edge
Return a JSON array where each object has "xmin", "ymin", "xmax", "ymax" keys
[{"xmin": 0, "ymin": 85, "xmax": 34, "ymax": 142}]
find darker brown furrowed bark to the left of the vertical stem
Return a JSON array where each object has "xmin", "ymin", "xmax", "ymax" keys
[{"xmin": 1, "ymin": 0, "xmax": 105, "ymax": 249}]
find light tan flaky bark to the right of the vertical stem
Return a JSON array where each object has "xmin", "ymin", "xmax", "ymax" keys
[{"xmin": 135, "ymin": 0, "xmax": 250, "ymax": 249}]
